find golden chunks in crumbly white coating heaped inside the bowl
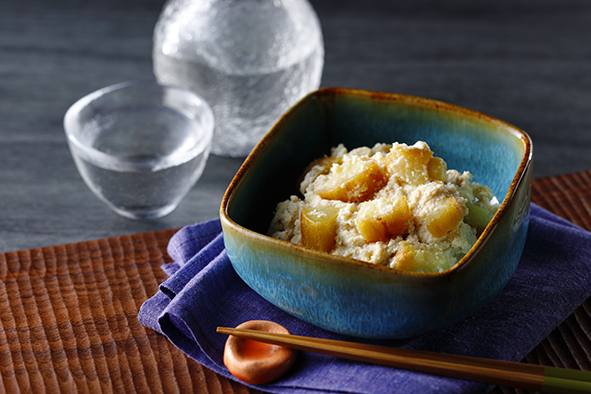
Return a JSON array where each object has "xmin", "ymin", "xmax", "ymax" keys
[{"xmin": 269, "ymin": 141, "xmax": 499, "ymax": 273}]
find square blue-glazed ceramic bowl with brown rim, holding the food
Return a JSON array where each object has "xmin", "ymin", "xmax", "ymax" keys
[{"xmin": 220, "ymin": 88, "xmax": 533, "ymax": 338}]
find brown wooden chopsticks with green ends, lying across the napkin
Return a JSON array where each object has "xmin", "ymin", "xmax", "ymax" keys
[{"xmin": 217, "ymin": 327, "xmax": 591, "ymax": 394}]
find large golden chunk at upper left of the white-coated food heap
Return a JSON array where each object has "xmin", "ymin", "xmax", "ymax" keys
[{"xmin": 316, "ymin": 160, "xmax": 388, "ymax": 203}]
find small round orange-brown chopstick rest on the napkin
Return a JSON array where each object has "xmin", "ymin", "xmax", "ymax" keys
[{"xmin": 224, "ymin": 320, "xmax": 297, "ymax": 384}]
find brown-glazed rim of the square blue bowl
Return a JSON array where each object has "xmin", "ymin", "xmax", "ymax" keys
[{"xmin": 220, "ymin": 87, "xmax": 533, "ymax": 280}]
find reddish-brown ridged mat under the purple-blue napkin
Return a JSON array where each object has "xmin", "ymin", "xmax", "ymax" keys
[{"xmin": 0, "ymin": 171, "xmax": 591, "ymax": 394}]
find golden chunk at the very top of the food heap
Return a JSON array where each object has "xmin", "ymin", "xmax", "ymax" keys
[{"xmin": 386, "ymin": 144, "xmax": 433, "ymax": 186}]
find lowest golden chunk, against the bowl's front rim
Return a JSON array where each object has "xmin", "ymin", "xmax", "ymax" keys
[{"xmin": 393, "ymin": 241, "xmax": 450, "ymax": 272}]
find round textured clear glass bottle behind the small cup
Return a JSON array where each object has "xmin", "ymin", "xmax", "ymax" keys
[{"xmin": 153, "ymin": 0, "xmax": 324, "ymax": 157}]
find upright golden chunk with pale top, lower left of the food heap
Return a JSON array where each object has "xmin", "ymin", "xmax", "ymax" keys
[{"xmin": 300, "ymin": 206, "xmax": 339, "ymax": 252}]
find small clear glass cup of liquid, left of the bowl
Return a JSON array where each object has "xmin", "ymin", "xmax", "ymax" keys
[{"xmin": 64, "ymin": 81, "xmax": 214, "ymax": 219}]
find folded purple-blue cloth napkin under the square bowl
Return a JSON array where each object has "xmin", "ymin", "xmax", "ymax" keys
[{"xmin": 139, "ymin": 204, "xmax": 591, "ymax": 394}]
